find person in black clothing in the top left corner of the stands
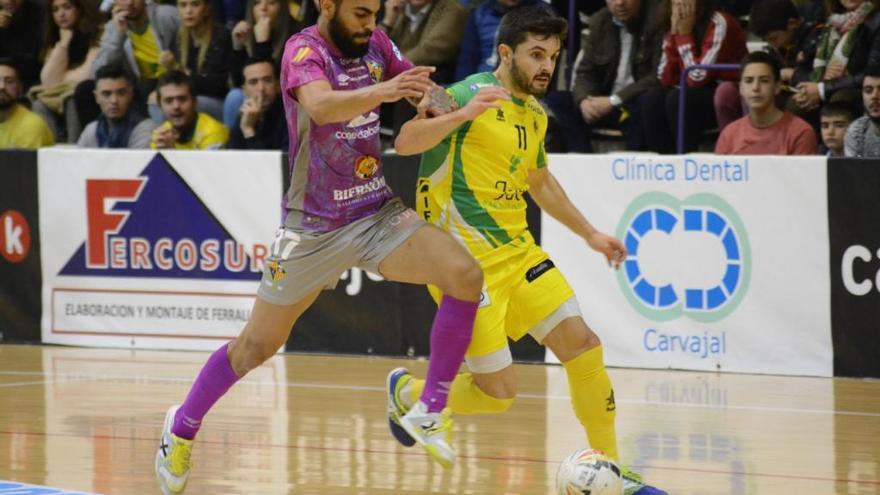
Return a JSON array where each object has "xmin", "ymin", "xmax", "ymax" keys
[{"xmin": 0, "ymin": 0, "xmax": 45, "ymax": 91}]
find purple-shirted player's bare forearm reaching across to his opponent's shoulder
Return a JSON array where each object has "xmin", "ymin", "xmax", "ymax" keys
[{"xmin": 294, "ymin": 66, "xmax": 434, "ymax": 125}]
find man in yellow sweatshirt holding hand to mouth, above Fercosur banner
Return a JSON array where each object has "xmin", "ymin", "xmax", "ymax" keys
[{"xmin": 150, "ymin": 70, "xmax": 229, "ymax": 150}]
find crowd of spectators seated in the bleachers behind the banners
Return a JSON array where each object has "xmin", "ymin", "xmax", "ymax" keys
[{"xmin": 0, "ymin": 0, "xmax": 880, "ymax": 156}]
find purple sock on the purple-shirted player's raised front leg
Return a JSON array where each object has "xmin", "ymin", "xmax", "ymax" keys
[{"xmin": 420, "ymin": 296, "xmax": 479, "ymax": 412}]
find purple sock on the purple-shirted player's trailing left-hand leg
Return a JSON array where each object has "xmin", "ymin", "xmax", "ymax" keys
[{"xmin": 171, "ymin": 342, "xmax": 238, "ymax": 440}]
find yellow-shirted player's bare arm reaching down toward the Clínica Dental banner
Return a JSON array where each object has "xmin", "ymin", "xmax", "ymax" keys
[{"xmin": 527, "ymin": 167, "xmax": 626, "ymax": 268}]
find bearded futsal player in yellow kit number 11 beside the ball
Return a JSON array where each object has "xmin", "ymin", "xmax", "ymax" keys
[{"xmin": 387, "ymin": 2, "xmax": 665, "ymax": 495}]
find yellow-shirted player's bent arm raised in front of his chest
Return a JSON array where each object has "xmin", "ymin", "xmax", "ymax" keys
[{"xmin": 394, "ymin": 86, "xmax": 510, "ymax": 155}]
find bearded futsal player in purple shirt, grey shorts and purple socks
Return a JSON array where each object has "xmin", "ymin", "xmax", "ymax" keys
[{"xmin": 156, "ymin": 0, "xmax": 483, "ymax": 494}]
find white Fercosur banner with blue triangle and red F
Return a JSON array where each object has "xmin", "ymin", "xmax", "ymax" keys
[{"xmin": 38, "ymin": 148, "xmax": 282, "ymax": 350}]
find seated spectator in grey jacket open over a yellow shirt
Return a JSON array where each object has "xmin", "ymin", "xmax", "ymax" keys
[{"xmin": 74, "ymin": 0, "xmax": 180, "ymax": 132}]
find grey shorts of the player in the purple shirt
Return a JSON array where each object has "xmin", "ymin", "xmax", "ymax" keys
[{"xmin": 257, "ymin": 198, "xmax": 425, "ymax": 305}]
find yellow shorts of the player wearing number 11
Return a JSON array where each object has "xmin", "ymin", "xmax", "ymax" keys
[{"xmin": 428, "ymin": 244, "xmax": 574, "ymax": 364}]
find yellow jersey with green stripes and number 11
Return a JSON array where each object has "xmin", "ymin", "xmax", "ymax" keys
[{"xmin": 416, "ymin": 72, "xmax": 547, "ymax": 266}]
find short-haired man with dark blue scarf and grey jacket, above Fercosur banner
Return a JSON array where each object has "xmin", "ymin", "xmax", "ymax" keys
[{"xmin": 76, "ymin": 65, "xmax": 156, "ymax": 149}]
